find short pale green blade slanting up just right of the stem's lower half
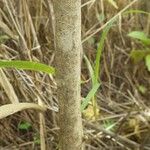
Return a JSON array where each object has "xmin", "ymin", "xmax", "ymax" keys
[{"xmin": 81, "ymin": 83, "xmax": 100, "ymax": 111}]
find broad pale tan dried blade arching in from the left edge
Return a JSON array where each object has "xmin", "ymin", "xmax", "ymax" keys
[{"xmin": 0, "ymin": 103, "xmax": 46, "ymax": 119}]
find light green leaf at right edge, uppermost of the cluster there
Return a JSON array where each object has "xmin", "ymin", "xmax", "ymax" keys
[{"xmin": 128, "ymin": 31, "xmax": 150, "ymax": 45}]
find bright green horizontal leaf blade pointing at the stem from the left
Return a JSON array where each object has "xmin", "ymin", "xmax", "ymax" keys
[{"xmin": 0, "ymin": 60, "xmax": 55, "ymax": 74}]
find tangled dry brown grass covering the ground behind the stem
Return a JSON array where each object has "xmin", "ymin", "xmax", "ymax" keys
[{"xmin": 0, "ymin": 0, "xmax": 150, "ymax": 150}]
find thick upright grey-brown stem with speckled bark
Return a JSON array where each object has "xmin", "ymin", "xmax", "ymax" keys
[{"xmin": 54, "ymin": 0, "xmax": 83, "ymax": 150}]
